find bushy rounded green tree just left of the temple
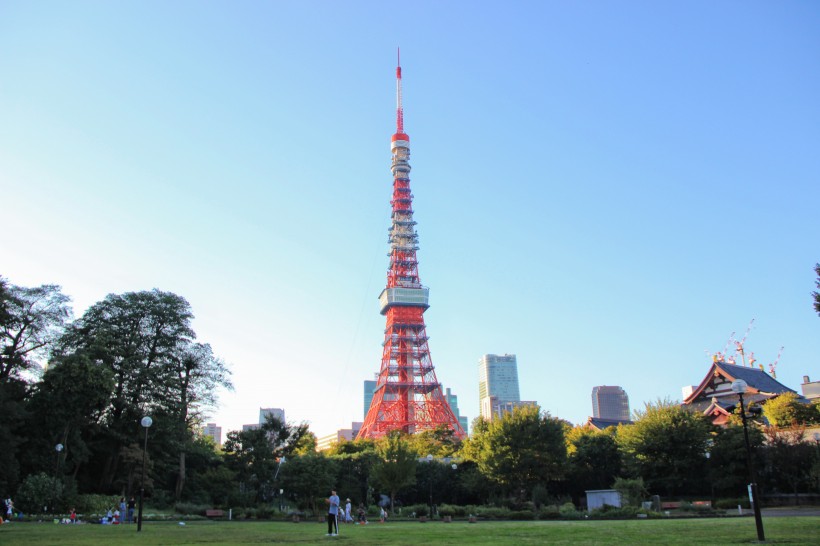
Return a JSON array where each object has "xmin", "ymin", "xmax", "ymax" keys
[{"xmin": 617, "ymin": 400, "xmax": 713, "ymax": 495}]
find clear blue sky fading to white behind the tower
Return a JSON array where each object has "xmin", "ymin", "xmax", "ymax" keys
[{"xmin": 0, "ymin": 0, "xmax": 820, "ymax": 435}]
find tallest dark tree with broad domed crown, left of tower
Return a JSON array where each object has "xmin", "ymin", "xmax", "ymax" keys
[{"xmin": 55, "ymin": 289, "xmax": 230, "ymax": 494}]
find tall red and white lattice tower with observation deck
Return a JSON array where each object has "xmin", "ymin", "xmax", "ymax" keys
[{"xmin": 357, "ymin": 55, "xmax": 465, "ymax": 438}]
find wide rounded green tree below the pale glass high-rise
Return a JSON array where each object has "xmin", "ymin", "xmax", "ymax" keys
[{"xmin": 461, "ymin": 406, "xmax": 568, "ymax": 498}]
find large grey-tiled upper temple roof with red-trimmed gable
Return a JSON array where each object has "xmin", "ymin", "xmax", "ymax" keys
[{"xmin": 683, "ymin": 360, "xmax": 795, "ymax": 411}]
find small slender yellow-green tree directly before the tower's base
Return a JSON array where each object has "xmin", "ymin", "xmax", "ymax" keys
[{"xmin": 371, "ymin": 430, "xmax": 419, "ymax": 512}]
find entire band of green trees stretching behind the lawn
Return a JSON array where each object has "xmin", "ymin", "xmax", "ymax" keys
[{"xmin": 0, "ymin": 272, "xmax": 820, "ymax": 513}]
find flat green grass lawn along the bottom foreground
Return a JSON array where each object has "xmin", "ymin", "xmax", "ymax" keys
[{"xmin": 0, "ymin": 516, "xmax": 820, "ymax": 546}]
